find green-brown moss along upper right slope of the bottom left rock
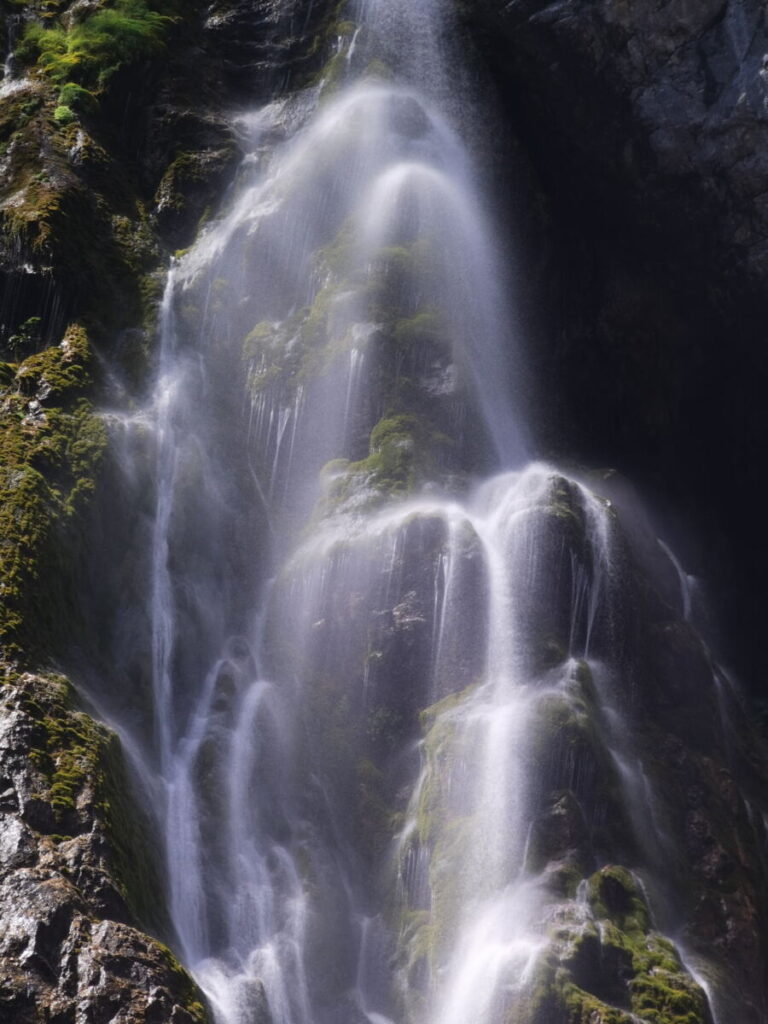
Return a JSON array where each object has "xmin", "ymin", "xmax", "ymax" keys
[{"xmin": 0, "ymin": 667, "xmax": 208, "ymax": 1024}]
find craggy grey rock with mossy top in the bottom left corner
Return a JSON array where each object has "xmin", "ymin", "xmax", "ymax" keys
[{"xmin": 0, "ymin": 673, "xmax": 206, "ymax": 1024}]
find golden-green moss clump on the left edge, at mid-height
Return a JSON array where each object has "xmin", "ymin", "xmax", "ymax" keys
[{"xmin": 0, "ymin": 325, "xmax": 105, "ymax": 656}]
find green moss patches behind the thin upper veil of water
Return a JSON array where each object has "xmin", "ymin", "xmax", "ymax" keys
[{"xmin": 237, "ymin": 224, "xmax": 466, "ymax": 515}]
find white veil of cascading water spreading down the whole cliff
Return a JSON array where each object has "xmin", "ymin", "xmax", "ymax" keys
[{"xmin": 93, "ymin": 0, "xmax": 761, "ymax": 1024}]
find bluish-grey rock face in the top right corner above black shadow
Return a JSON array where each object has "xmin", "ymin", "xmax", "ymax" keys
[{"xmin": 481, "ymin": 0, "xmax": 768, "ymax": 281}]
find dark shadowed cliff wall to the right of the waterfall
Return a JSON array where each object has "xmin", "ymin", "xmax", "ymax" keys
[{"xmin": 463, "ymin": 0, "xmax": 768, "ymax": 686}]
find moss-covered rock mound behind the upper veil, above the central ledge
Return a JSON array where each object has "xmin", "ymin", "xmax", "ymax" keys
[{"xmin": 243, "ymin": 223, "xmax": 485, "ymax": 517}]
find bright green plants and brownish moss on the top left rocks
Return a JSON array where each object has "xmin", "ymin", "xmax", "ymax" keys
[{"xmin": 0, "ymin": 9, "xmax": 178, "ymax": 336}]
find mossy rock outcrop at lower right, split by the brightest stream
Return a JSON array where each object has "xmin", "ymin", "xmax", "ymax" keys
[{"xmin": 372, "ymin": 475, "xmax": 765, "ymax": 1024}]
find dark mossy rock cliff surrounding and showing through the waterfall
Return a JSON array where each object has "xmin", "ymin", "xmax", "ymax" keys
[{"xmin": 0, "ymin": 0, "xmax": 768, "ymax": 1024}]
